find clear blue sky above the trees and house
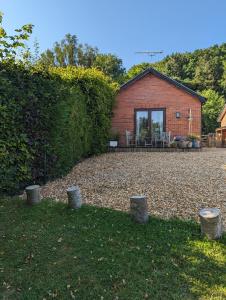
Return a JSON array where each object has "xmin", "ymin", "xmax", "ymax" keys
[{"xmin": 0, "ymin": 0, "xmax": 226, "ymax": 68}]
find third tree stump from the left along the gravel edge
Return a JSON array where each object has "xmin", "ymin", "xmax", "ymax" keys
[{"xmin": 130, "ymin": 196, "xmax": 148, "ymax": 223}]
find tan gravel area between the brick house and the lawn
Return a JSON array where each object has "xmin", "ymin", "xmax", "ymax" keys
[{"xmin": 42, "ymin": 149, "xmax": 226, "ymax": 224}]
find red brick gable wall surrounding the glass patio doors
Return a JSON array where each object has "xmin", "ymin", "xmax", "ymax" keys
[{"xmin": 112, "ymin": 74, "xmax": 201, "ymax": 144}]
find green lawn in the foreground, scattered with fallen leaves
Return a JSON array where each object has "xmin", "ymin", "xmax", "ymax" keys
[{"xmin": 0, "ymin": 199, "xmax": 226, "ymax": 300}]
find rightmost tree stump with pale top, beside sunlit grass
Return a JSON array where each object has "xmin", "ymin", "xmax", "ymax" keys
[{"xmin": 199, "ymin": 208, "xmax": 223, "ymax": 240}]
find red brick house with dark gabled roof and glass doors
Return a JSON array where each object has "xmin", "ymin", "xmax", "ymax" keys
[{"xmin": 112, "ymin": 68, "xmax": 206, "ymax": 146}]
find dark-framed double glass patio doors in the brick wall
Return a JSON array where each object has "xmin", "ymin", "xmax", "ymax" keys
[{"xmin": 135, "ymin": 109, "xmax": 165, "ymax": 145}]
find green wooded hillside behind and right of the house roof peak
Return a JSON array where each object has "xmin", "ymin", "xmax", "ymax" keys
[{"xmin": 127, "ymin": 43, "xmax": 226, "ymax": 95}]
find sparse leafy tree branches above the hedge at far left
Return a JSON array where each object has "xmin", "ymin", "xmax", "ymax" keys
[{"xmin": 0, "ymin": 12, "xmax": 33, "ymax": 61}]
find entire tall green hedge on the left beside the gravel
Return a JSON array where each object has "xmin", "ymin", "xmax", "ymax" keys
[{"xmin": 0, "ymin": 63, "xmax": 117, "ymax": 193}]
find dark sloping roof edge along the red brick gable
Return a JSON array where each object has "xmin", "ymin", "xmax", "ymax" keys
[{"xmin": 120, "ymin": 68, "xmax": 206, "ymax": 103}]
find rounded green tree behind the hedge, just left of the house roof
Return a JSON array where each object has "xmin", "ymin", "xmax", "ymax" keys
[{"xmin": 93, "ymin": 54, "xmax": 125, "ymax": 83}]
